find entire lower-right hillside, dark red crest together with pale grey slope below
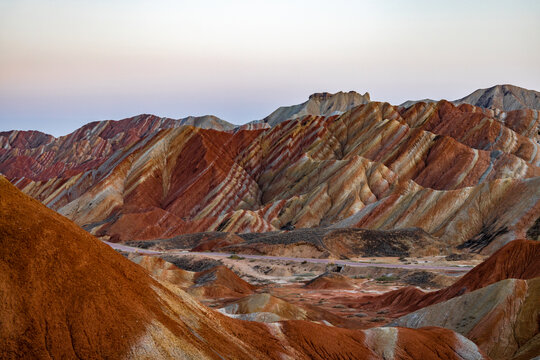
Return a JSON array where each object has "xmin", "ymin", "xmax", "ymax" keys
[{"xmin": 359, "ymin": 240, "xmax": 540, "ymax": 359}]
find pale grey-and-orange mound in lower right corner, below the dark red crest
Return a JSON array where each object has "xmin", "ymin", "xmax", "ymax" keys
[{"xmin": 390, "ymin": 277, "xmax": 540, "ymax": 359}]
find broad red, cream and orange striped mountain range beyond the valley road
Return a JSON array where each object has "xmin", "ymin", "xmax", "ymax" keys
[{"xmin": 2, "ymin": 97, "xmax": 540, "ymax": 252}]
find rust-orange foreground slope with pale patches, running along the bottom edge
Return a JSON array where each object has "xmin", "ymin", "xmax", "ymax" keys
[{"xmin": 0, "ymin": 177, "xmax": 486, "ymax": 359}]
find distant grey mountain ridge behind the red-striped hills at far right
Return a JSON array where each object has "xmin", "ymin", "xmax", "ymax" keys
[{"xmin": 400, "ymin": 84, "xmax": 540, "ymax": 111}]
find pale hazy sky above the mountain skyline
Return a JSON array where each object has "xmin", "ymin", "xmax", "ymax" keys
[{"xmin": 0, "ymin": 0, "xmax": 540, "ymax": 136}]
